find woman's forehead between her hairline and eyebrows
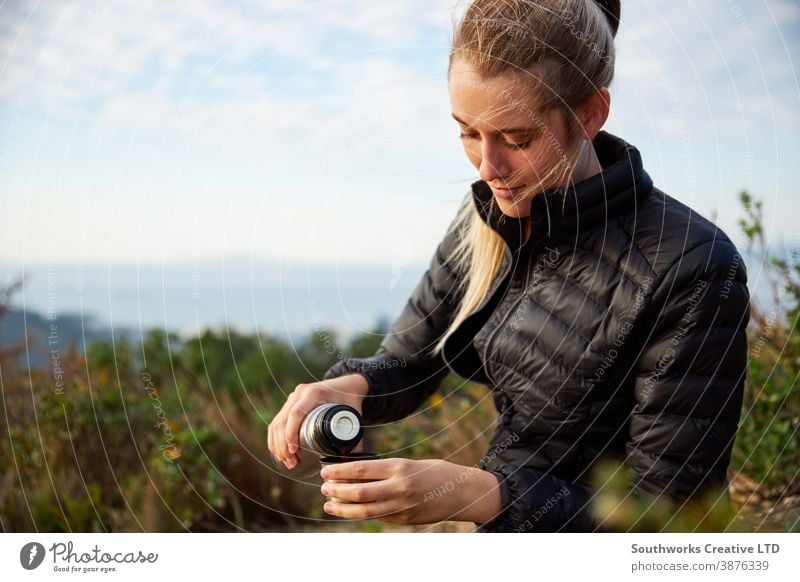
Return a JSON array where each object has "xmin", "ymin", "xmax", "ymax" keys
[{"xmin": 448, "ymin": 59, "xmax": 548, "ymax": 128}]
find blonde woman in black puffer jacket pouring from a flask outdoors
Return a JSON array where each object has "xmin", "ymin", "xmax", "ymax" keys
[{"xmin": 269, "ymin": 0, "xmax": 749, "ymax": 531}]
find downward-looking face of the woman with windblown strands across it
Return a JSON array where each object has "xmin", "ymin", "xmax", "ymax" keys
[{"xmin": 449, "ymin": 59, "xmax": 568, "ymax": 217}]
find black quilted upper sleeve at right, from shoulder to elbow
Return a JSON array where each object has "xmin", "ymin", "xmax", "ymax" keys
[{"xmin": 626, "ymin": 239, "xmax": 750, "ymax": 501}]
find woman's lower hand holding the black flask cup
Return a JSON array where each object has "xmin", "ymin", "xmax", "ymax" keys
[{"xmin": 320, "ymin": 459, "xmax": 500, "ymax": 524}]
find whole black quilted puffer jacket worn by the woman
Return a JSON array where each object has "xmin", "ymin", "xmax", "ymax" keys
[{"xmin": 325, "ymin": 132, "xmax": 749, "ymax": 531}]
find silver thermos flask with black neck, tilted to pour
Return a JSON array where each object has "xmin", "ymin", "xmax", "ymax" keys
[{"xmin": 272, "ymin": 404, "xmax": 364, "ymax": 479}]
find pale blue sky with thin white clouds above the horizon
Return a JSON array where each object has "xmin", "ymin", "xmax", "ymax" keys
[{"xmin": 0, "ymin": 0, "xmax": 800, "ymax": 265}]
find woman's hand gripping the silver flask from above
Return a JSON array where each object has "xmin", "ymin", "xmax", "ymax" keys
[{"xmin": 267, "ymin": 374, "xmax": 369, "ymax": 469}]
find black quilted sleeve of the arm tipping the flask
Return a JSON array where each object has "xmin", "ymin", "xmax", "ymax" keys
[{"xmin": 323, "ymin": 213, "xmax": 466, "ymax": 424}]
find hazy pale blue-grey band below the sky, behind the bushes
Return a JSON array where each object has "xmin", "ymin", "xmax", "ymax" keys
[{"xmin": 0, "ymin": 256, "xmax": 427, "ymax": 338}]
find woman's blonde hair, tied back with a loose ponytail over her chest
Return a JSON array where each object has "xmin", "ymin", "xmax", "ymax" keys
[{"xmin": 431, "ymin": 0, "xmax": 620, "ymax": 355}]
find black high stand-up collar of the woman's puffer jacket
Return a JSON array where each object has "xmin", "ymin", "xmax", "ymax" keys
[{"xmin": 472, "ymin": 131, "xmax": 653, "ymax": 252}]
